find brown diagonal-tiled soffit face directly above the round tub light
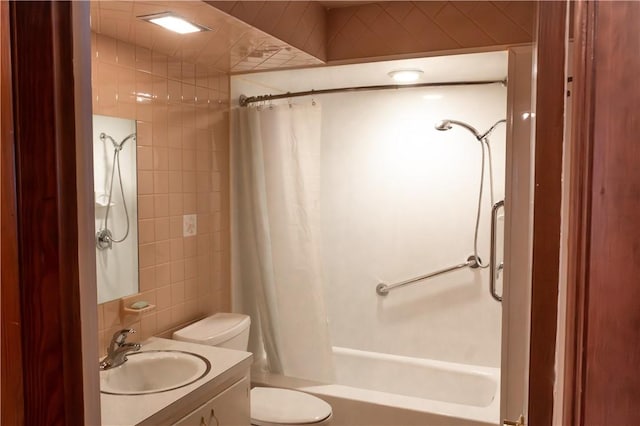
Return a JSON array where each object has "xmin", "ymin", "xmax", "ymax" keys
[{"xmin": 327, "ymin": 1, "xmax": 535, "ymax": 61}]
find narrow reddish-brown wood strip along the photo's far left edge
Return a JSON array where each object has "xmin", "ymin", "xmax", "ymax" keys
[{"xmin": 0, "ymin": 1, "xmax": 24, "ymax": 425}]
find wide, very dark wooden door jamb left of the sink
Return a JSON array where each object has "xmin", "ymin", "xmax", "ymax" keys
[{"xmin": 10, "ymin": 2, "xmax": 84, "ymax": 425}]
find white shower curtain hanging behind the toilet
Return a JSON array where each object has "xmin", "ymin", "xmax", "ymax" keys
[{"xmin": 232, "ymin": 104, "xmax": 333, "ymax": 382}]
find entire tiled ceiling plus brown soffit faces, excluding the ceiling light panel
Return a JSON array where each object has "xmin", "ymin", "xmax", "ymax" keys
[{"xmin": 91, "ymin": 1, "xmax": 535, "ymax": 73}]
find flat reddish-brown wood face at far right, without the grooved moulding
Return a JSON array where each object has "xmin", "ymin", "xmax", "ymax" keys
[{"xmin": 581, "ymin": 1, "xmax": 640, "ymax": 425}]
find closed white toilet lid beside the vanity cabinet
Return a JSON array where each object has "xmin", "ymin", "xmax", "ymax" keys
[{"xmin": 251, "ymin": 387, "xmax": 331, "ymax": 426}]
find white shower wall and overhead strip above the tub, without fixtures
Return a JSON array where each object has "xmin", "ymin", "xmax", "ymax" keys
[{"xmin": 231, "ymin": 52, "xmax": 508, "ymax": 367}]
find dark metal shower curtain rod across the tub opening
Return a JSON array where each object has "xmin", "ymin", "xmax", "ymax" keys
[{"xmin": 240, "ymin": 78, "xmax": 507, "ymax": 107}]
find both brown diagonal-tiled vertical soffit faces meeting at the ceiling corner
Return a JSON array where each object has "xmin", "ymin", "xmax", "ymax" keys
[{"xmin": 208, "ymin": 1, "xmax": 535, "ymax": 62}]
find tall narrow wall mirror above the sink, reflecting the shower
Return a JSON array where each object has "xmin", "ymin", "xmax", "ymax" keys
[{"xmin": 93, "ymin": 115, "xmax": 138, "ymax": 303}]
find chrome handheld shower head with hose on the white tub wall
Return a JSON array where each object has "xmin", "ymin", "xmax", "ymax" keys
[{"xmin": 434, "ymin": 119, "xmax": 507, "ymax": 268}]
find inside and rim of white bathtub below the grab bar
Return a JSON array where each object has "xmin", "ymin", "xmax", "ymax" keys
[{"xmin": 324, "ymin": 347, "xmax": 500, "ymax": 425}]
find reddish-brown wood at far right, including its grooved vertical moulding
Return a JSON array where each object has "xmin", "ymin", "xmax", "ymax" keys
[{"xmin": 564, "ymin": 1, "xmax": 640, "ymax": 425}]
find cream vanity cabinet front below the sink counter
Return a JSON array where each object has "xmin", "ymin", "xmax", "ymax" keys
[{"xmin": 175, "ymin": 377, "xmax": 251, "ymax": 426}]
